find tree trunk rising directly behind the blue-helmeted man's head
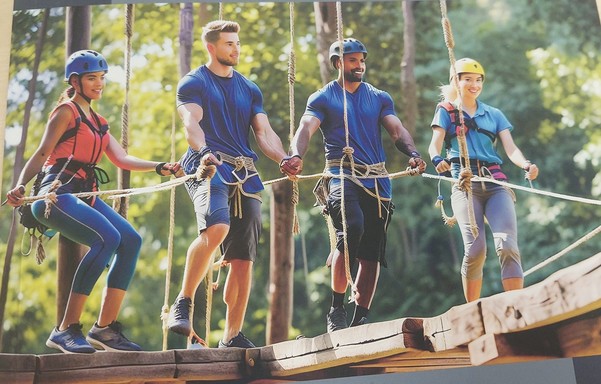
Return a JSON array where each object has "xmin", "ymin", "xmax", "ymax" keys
[{"xmin": 313, "ymin": 2, "xmax": 336, "ymax": 84}]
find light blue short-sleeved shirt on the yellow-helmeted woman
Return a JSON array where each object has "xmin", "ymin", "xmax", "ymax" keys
[{"xmin": 431, "ymin": 101, "xmax": 513, "ymax": 164}]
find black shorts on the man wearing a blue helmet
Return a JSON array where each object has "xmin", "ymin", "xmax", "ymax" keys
[{"xmin": 327, "ymin": 180, "xmax": 394, "ymax": 267}]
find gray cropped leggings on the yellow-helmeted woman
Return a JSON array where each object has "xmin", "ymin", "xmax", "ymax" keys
[{"xmin": 451, "ymin": 182, "xmax": 524, "ymax": 280}]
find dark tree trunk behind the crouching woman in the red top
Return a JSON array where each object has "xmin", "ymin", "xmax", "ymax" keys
[{"xmin": 56, "ymin": 6, "xmax": 92, "ymax": 324}]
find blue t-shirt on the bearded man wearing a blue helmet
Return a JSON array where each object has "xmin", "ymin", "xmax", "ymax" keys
[{"xmin": 305, "ymin": 81, "xmax": 395, "ymax": 198}]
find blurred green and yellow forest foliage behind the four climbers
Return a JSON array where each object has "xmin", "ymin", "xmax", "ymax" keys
[{"xmin": 0, "ymin": 0, "xmax": 601, "ymax": 354}]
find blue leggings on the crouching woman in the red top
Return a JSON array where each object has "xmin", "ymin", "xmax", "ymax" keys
[{"xmin": 31, "ymin": 193, "xmax": 142, "ymax": 295}]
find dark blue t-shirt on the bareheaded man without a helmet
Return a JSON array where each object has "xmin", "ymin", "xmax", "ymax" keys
[{"xmin": 176, "ymin": 65, "xmax": 265, "ymax": 193}]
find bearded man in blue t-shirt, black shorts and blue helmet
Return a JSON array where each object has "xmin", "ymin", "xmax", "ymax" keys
[{"xmin": 291, "ymin": 38, "xmax": 426, "ymax": 332}]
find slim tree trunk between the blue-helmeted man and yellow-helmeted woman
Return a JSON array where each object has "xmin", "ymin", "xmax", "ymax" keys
[{"xmin": 401, "ymin": 0, "xmax": 417, "ymax": 136}]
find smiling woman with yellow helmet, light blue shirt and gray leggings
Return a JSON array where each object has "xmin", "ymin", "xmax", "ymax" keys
[{"xmin": 428, "ymin": 58, "xmax": 538, "ymax": 302}]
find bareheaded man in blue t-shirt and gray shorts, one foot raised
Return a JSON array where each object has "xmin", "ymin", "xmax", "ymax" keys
[{"xmin": 168, "ymin": 21, "xmax": 300, "ymax": 348}]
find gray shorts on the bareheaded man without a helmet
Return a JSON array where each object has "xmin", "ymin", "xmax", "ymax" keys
[{"xmin": 185, "ymin": 178, "xmax": 261, "ymax": 262}]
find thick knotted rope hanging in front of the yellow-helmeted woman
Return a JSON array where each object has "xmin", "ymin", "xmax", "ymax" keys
[{"xmin": 437, "ymin": 0, "xmax": 478, "ymax": 237}]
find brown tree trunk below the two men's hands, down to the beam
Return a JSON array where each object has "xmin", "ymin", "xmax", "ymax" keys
[{"xmin": 267, "ymin": 181, "xmax": 294, "ymax": 345}]
